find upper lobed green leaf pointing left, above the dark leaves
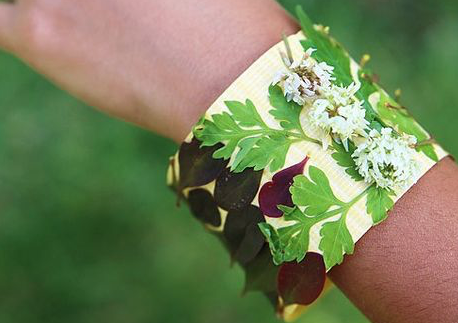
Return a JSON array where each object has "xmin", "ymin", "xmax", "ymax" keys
[{"xmin": 194, "ymin": 99, "xmax": 300, "ymax": 173}]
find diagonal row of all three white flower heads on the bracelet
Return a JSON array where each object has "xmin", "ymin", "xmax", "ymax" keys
[{"xmin": 272, "ymin": 49, "xmax": 419, "ymax": 189}]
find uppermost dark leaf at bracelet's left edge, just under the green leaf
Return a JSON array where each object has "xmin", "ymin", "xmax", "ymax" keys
[{"xmin": 178, "ymin": 138, "xmax": 227, "ymax": 191}]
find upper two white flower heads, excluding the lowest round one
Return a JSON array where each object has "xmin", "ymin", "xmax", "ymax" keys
[{"xmin": 272, "ymin": 48, "xmax": 369, "ymax": 150}]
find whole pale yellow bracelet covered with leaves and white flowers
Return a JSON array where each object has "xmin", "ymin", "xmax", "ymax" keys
[{"xmin": 168, "ymin": 8, "xmax": 447, "ymax": 320}]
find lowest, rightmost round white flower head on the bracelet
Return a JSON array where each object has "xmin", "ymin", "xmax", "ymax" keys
[{"xmin": 352, "ymin": 128, "xmax": 419, "ymax": 189}]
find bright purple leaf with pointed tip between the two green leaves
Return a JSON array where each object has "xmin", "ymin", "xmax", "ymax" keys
[{"xmin": 259, "ymin": 157, "xmax": 308, "ymax": 218}]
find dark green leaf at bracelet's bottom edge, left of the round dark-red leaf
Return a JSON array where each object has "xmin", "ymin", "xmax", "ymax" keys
[{"xmin": 244, "ymin": 244, "xmax": 279, "ymax": 294}]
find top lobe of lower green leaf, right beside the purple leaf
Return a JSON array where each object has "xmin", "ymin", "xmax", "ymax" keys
[{"xmin": 290, "ymin": 166, "xmax": 344, "ymax": 215}]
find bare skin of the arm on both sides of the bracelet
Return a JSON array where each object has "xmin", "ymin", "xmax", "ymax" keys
[{"xmin": 0, "ymin": 0, "xmax": 458, "ymax": 323}]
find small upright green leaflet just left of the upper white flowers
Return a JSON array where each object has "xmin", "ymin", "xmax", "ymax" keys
[{"xmin": 269, "ymin": 85, "xmax": 302, "ymax": 132}]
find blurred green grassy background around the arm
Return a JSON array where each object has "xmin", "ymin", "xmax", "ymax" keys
[{"xmin": 0, "ymin": 0, "xmax": 458, "ymax": 323}]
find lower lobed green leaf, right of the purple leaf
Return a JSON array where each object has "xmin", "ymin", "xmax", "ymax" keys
[{"xmin": 259, "ymin": 166, "xmax": 367, "ymax": 270}]
